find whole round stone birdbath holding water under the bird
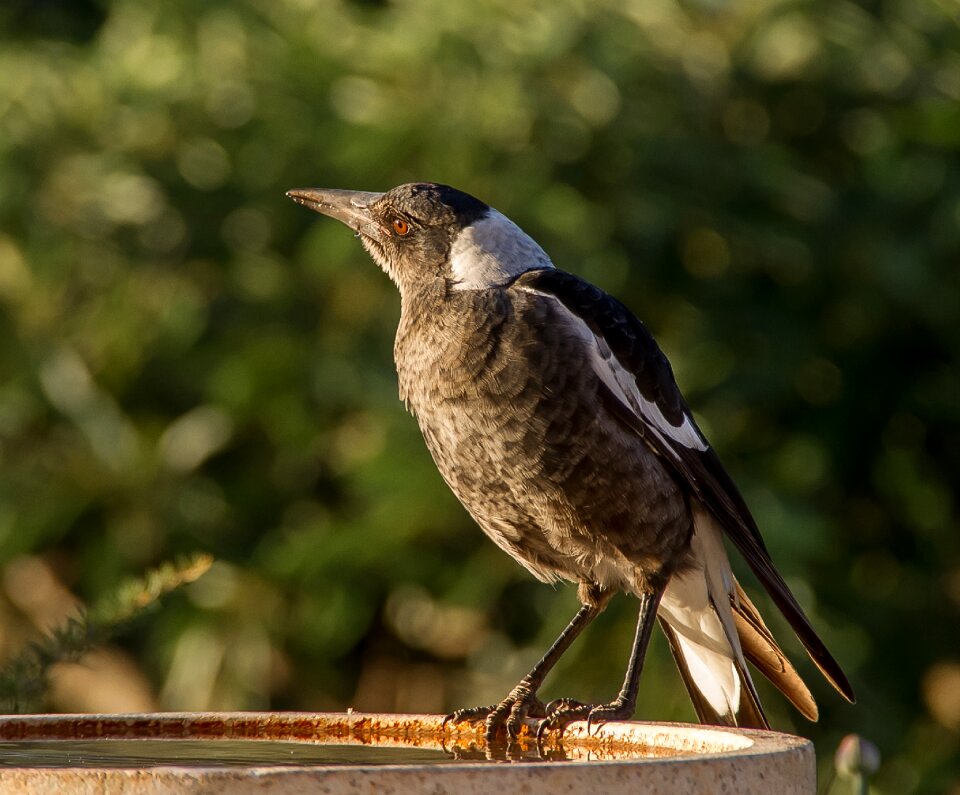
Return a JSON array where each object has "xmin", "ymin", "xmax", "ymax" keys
[{"xmin": 0, "ymin": 712, "xmax": 816, "ymax": 795}]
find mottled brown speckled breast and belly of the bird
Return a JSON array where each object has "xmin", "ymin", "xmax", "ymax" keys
[{"xmin": 394, "ymin": 281, "xmax": 691, "ymax": 591}]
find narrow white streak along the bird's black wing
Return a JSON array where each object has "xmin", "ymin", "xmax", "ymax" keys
[{"xmin": 524, "ymin": 288, "xmax": 707, "ymax": 451}]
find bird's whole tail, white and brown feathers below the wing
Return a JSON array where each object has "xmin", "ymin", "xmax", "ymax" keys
[{"xmin": 658, "ymin": 509, "xmax": 817, "ymax": 729}]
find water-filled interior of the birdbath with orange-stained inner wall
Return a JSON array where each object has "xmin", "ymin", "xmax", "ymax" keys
[{"xmin": 0, "ymin": 713, "xmax": 720, "ymax": 769}]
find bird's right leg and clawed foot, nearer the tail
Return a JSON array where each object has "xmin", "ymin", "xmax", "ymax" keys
[{"xmin": 537, "ymin": 587, "xmax": 664, "ymax": 740}]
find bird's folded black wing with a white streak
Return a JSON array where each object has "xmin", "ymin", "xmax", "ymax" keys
[{"xmin": 512, "ymin": 268, "xmax": 854, "ymax": 701}]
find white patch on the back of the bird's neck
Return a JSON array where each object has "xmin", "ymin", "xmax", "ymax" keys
[{"xmin": 450, "ymin": 207, "xmax": 553, "ymax": 290}]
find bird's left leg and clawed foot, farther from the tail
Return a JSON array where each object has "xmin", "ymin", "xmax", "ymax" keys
[{"xmin": 443, "ymin": 583, "xmax": 612, "ymax": 743}]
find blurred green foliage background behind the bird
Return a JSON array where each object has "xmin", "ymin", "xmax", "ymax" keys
[{"xmin": 0, "ymin": 0, "xmax": 960, "ymax": 795}]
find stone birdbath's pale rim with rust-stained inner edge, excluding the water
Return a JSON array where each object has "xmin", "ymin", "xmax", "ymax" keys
[{"xmin": 0, "ymin": 710, "xmax": 815, "ymax": 795}]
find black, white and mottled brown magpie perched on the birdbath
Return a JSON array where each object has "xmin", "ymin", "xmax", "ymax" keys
[{"xmin": 287, "ymin": 182, "xmax": 855, "ymax": 743}]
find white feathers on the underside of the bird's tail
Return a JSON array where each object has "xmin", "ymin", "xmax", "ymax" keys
[{"xmin": 658, "ymin": 505, "xmax": 755, "ymax": 716}]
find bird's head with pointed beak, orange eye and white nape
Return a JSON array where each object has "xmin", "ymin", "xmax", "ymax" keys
[{"xmin": 287, "ymin": 182, "xmax": 552, "ymax": 292}]
